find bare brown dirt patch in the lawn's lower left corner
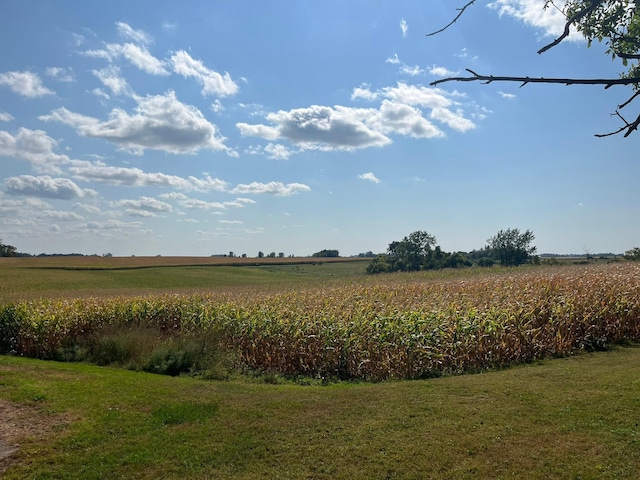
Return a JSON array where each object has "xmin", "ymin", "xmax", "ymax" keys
[{"xmin": 0, "ymin": 399, "xmax": 61, "ymax": 474}]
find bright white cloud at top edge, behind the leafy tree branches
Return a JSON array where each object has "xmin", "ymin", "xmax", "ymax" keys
[{"xmin": 487, "ymin": 0, "xmax": 583, "ymax": 41}]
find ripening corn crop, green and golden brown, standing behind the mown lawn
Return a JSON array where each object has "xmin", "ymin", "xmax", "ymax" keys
[{"xmin": 0, "ymin": 263, "xmax": 640, "ymax": 380}]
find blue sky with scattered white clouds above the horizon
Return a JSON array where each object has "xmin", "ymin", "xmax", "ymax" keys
[{"xmin": 0, "ymin": 0, "xmax": 640, "ymax": 257}]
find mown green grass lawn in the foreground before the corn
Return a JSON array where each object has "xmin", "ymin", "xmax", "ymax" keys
[{"xmin": 0, "ymin": 347, "xmax": 640, "ymax": 479}]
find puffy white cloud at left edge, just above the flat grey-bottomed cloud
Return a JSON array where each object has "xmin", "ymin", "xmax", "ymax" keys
[{"xmin": 0, "ymin": 127, "xmax": 71, "ymax": 174}]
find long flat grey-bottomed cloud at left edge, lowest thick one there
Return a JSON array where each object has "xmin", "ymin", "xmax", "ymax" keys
[{"xmin": 4, "ymin": 175, "xmax": 96, "ymax": 200}]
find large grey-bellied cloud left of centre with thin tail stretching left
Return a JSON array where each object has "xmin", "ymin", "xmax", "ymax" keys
[{"xmin": 39, "ymin": 91, "xmax": 233, "ymax": 155}]
